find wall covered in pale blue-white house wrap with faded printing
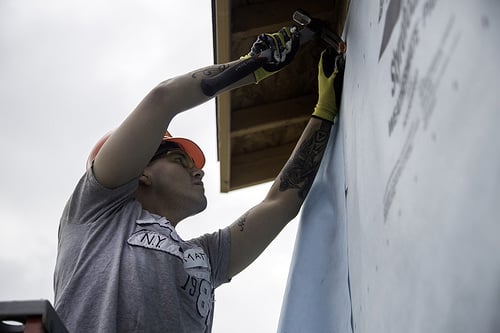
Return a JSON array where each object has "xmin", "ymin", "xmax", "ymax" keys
[{"xmin": 279, "ymin": 0, "xmax": 500, "ymax": 332}]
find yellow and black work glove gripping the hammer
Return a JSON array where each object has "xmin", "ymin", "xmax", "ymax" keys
[{"xmin": 241, "ymin": 27, "xmax": 299, "ymax": 83}]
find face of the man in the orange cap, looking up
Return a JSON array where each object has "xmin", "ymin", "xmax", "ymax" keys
[{"xmin": 149, "ymin": 149, "xmax": 207, "ymax": 216}]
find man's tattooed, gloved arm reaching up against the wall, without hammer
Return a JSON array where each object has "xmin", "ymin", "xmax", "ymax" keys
[{"xmin": 229, "ymin": 50, "xmax": 343, "ymax": 277}]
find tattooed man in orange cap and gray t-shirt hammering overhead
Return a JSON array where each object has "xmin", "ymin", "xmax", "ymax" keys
[{"xmin": 54, "ymin": 28, "xmax": 341, "ymax": 333}]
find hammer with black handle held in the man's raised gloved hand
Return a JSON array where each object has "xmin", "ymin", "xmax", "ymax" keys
[{"xmin": 201, "ymin": 9, "xmax": 346, "ymax": 96}]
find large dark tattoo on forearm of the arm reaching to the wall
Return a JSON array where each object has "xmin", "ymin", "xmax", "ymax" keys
[{"xmin": 279, "ymin": 121, "xmax": 331, "ymax": 200}]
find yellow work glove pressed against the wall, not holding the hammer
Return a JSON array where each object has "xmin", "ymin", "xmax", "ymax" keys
[{"xmin": 312, "ymin": 48, "xmax": 344, "ymax": 122}]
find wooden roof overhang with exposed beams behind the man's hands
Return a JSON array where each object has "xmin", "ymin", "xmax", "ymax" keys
[{"xmin": 212, "ymin": 0, "xmax": 348, "ymax": 192}]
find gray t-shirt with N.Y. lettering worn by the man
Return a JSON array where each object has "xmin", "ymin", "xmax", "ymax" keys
[{"xmin": 54, "ymin": 170, "xmax": 230, "ymax": 333}]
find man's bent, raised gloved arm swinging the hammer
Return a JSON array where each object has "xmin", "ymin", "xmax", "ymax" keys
[{"xmin": 93, "ymin": 29, "xmax": 298, "ymax": 188}]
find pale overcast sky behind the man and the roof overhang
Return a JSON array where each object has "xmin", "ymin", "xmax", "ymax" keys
[{"xmin": 0, "ymin": 0, "xmax": 297, "ymax": 332}]
